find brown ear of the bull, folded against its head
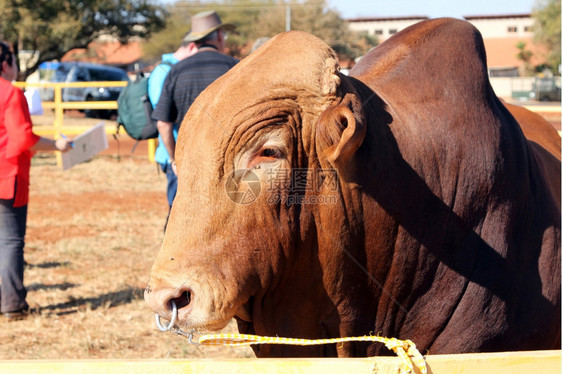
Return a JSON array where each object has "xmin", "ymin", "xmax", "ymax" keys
[{"xmin": 317, "ymin": 103, "xmax": 367, "ymax": 165}]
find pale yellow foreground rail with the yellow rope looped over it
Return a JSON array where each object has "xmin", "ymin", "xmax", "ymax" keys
[{"xmin": 0, "ymin": 350, "xmax": 561, "ymax": 374}]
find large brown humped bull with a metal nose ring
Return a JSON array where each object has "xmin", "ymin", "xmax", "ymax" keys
[{"xmin": 145, "ymin": 19, "xmax": 560, "ymax": 357}]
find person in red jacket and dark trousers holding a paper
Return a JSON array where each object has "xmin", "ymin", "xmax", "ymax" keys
[{"xmin": 0, "ymin": 42, "xmax": 72, "ymax": 320}]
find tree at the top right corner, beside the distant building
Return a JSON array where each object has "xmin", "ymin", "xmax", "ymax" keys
[{"xmin": 533, "ymin": 0, "xmax": 561, "ymax": 74}]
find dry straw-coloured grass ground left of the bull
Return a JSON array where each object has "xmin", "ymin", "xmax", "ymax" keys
[{"xmin": 0, "ymin": 138, "xmax": 253, "ymax": 359}]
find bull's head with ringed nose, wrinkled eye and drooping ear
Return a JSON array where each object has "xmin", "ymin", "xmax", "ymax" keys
[{"xmin": 145, "ymin": 32, "xmax": 372, "ymax": 356}]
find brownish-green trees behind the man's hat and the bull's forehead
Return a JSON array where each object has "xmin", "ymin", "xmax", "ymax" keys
[{"xmin": 143, "ymin": 0, "xmax": 377, "ymax": 61}]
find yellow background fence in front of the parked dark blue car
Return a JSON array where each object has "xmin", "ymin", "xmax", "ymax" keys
[{"xmin": 14, "ymin": 81, "xmax": 156, "ymax": 165}]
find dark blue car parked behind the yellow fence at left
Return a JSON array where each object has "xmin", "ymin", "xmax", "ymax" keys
[{"xmin": 40, "ymin": 62, "xmax": 129, "ymax": 118}]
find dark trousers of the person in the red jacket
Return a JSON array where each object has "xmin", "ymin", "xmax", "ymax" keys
[{"xmin": 0, "ymin": 199, "xmax": 28, "ymax": 313}]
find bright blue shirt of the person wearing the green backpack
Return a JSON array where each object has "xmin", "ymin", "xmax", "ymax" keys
[{"xmin": 148, "ymin": 53, "xmax": 179, "ymax": 164}]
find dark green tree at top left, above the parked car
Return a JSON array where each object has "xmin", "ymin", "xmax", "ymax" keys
[{"xmin": 0, "ymin": 0, "xmax": 166, "ymax": 79}]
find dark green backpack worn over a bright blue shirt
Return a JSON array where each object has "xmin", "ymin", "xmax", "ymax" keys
[{"xmin": 117, "ymin": 61, "xmax": 171, "ymax": 140}]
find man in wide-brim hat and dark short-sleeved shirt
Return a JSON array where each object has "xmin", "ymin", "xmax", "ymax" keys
[{"xmin": 152, "ymin": 11, "xmax": 238, "ymax": 174}]
